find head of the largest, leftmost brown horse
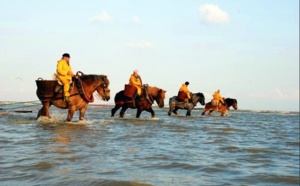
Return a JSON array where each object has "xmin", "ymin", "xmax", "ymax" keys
[{"xmin": 96, "ymin": 75, "xmax": 110, "ymax": 101}]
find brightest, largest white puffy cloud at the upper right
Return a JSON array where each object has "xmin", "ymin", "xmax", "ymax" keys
[{"xmin": 199, "ymin": 4, "xmax": 230, "ymax": 24}]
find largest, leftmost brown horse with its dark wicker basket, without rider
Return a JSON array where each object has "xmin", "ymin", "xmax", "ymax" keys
[{"xmin": 36, "ymin": 72, "xmax": 110, "ymax": 121}]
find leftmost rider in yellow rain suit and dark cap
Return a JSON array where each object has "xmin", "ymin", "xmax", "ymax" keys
[{"xmin": 56, "ymin": 53, "xmax": 74, "ymax": 102}]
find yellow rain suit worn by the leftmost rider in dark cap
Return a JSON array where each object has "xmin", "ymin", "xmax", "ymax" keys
[{"xmin": 56, "ymin": 59, "xmax": 74, "ymax": 97}]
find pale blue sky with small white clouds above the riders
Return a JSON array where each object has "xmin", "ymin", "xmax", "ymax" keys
[{"xmin": 0, "ymin": 0, "xmax": 299, "ymax": 112}]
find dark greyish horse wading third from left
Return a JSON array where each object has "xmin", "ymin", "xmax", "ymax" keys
[{"xmin": 168, "ymin": 92, "xmax": 205, "ymax": 116}]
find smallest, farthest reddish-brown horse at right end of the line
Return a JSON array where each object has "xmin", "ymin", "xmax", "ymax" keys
[{"xmin": 202, "ymin": 98, "xmax": 238, "ymax": 116}]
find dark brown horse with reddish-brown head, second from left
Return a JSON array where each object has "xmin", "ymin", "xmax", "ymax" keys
[{"xmin": 111, "ymin": 85, "xmax": 166, "ymax": 118}]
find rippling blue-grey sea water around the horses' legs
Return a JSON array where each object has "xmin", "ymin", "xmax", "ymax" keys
[{"xmin": 0, "ymin": 103, "xmax": 300, "ymax": 186}]
